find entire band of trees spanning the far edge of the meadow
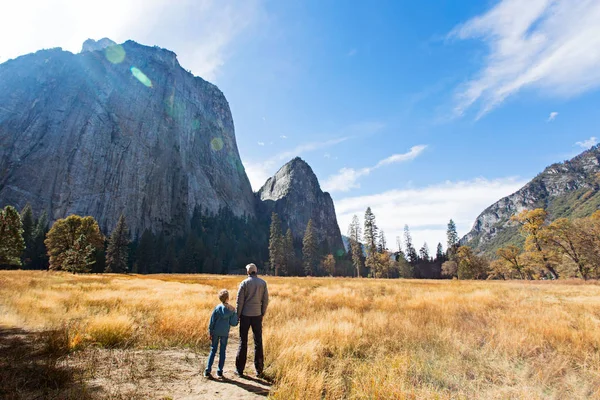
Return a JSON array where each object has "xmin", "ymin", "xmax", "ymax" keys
[{"xmin": 0, "ymin": 205, "xmax": 600, "ymax": 279}]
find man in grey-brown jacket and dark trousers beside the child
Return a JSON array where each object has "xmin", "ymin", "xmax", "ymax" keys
[{"xmin": 235, "ymin": 264, "xmax": 269, "ymax": 377}]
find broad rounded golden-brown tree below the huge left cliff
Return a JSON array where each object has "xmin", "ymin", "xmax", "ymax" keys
[{"xmin": 45, "ymin": 215, "xmax": 104, "ymax": 272}]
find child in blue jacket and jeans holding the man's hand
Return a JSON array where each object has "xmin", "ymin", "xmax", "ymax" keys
[{"xmin": 204, "ymin": 289, "xmax": 238, "ymax": 378}]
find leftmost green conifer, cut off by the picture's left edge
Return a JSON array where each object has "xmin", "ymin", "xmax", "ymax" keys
[{"xmin": 0, "ymin": 206, "xmax": 25, "ymax": 266}]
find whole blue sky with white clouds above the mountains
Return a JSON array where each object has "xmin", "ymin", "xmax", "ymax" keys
[{"xmin": 0, "ymin": 0, "xmax": 600, "ymax": 249}]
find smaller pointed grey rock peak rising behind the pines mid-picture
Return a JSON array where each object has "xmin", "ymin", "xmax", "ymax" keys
[{"xmin": 257, "ymin": 157, "xmax": 344, "ymax": 254}]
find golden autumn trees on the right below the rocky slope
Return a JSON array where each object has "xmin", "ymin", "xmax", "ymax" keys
[{"xmin": 442, "ymin": 208, "xmax": 600, "ymax": 280}]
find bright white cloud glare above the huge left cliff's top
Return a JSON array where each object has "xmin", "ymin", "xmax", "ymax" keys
[{"xmin": 0, "ymin": 0, "xmax": 260, "ymax": 81}]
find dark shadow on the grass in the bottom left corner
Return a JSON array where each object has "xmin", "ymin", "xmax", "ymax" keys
[{"xmin": 0, "ymin": 326, "xmax": 92, "ymax": 400}]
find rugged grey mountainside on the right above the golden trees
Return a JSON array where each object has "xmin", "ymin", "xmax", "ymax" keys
[{"xmin": 461, "ymin": 146, "xmax": 600, "ymax": 253}]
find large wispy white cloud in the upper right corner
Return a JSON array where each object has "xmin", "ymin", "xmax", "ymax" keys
[{"xmin": 449, "ymin": 0, "xmax": 600, "ymax": 117}]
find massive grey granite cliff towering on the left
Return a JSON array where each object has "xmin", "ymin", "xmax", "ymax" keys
[{"xmin": 0, "ymin": 41, "xmax": 255, "ymax": 237}]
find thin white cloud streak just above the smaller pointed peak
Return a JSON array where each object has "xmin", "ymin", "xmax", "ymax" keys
[{"xmin": 244, "ymin": 137, "xmax": 348, "ymax": 190}]
